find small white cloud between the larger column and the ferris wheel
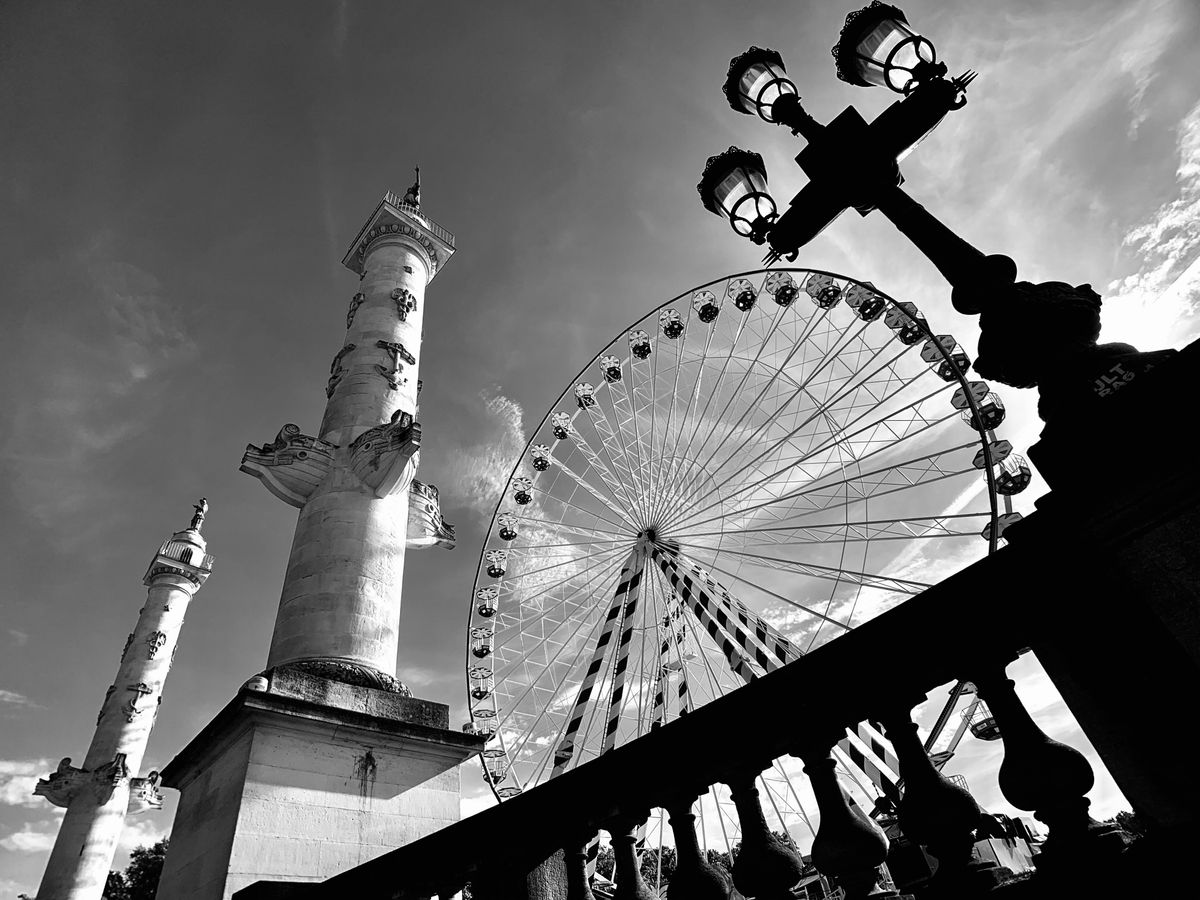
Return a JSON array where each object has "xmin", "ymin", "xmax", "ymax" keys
[{"xmin": 442, "ymin": 385, "xmax": 526, "ymax": 518}]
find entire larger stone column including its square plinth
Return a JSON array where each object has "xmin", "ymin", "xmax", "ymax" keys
[{"xmin": 158, "ymin": 173, "xmax": 481, "ymax": 900}]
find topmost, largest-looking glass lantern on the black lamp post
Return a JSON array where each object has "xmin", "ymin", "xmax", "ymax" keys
[{"xmin": 833, "ymin": 0, "xmax": 944, "ymax": 94}]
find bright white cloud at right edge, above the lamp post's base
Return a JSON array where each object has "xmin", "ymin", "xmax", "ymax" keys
[{"xmin": 1104, "ymin": 103, "xmax": 1200, "ymax": 349}]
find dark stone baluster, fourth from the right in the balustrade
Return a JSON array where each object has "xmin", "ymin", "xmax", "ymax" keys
[{"xmin": 726, "ymin": 769, "xmax": 804, "ymax": 900}]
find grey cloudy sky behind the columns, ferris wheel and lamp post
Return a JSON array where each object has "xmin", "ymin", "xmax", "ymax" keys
[{"xmin": 0, "ymin": 0, "xmax": 1200, "ymax": 896}]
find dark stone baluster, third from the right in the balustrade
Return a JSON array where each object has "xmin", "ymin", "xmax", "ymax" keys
[{"xmin": 799, "ymin": 745, "xmax": 895, "ymax": 900}]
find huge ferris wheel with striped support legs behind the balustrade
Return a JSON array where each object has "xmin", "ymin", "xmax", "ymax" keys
[{"xmin": 466, "ymin": 269, "xmax": 1031, "ymax": 868}]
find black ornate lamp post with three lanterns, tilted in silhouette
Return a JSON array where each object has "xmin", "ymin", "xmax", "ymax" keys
[{"xmin": 697, "ymin": 0, "xmax": 1163, "ymax": 422}]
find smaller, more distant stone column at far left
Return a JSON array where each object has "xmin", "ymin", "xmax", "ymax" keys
[{"xmin": 35, "ymin": 500, "xmax": 212, "ymax": 900}]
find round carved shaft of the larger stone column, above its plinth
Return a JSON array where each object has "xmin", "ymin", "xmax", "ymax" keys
[{"xmin": 242, "ymin": 194, "xmax": 454, "ymax": 691}]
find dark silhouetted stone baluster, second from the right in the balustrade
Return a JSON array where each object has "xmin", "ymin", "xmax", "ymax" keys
[{"xmin": 882, "ymin": 709, "xmax": 1003, "ymax": 896}]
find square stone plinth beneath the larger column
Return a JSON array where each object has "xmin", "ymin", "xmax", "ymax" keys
[{"xmin": 158, "ymin": 671, "xmax": 482, "ymax": 900}]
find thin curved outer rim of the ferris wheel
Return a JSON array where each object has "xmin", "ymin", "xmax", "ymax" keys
[{"xmin": 464, "ymin": 266, "xmax": 1012, "ymax": 802}]
